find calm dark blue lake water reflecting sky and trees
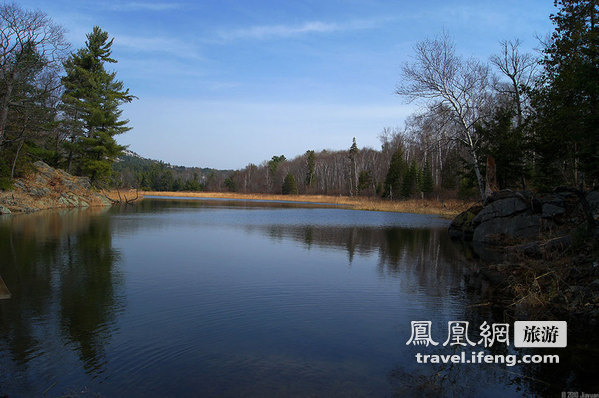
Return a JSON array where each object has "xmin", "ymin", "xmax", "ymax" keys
[{"xmin": 0, "ymin": 199, "xmax": 599, "ymax": 397}]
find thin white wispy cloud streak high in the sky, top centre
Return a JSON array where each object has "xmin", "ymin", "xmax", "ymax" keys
[{"xmin": 218, "ymin": 19, "xmax": 384, "ymax": 40}]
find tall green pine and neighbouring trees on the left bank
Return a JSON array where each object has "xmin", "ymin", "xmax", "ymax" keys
[{"xmin": 0, "ymin": 3, "xmax": 135, "ymax": 187}]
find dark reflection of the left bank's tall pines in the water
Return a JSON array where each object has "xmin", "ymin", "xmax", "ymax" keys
[{"xmin": 0, "ymin": 209, "xmax": 122, "ymax": 382}]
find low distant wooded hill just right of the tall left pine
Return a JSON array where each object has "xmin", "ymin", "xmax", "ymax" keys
[{"xmin": 112, "ymin": 149, "xmax": 233, "ymax": 191}]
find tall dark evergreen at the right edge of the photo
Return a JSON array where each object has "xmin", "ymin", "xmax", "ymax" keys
[{"xmin": 533, "ymin": 0, "xmax": 599, "ymax": 185}]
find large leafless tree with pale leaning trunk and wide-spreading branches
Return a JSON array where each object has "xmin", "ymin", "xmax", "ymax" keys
[{"xmin": 396, "ymin": 33, "xmax": 490, "ymax": 198}]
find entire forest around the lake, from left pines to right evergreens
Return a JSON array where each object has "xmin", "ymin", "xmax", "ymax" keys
[{"xmin": 0, "ymin": 0, "xmax": 599, "ymax": 199}]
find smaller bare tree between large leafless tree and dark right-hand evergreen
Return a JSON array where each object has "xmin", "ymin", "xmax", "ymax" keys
[{"xmin": 491, "ymin": 39, "xmax": 538, "ymax": 126}]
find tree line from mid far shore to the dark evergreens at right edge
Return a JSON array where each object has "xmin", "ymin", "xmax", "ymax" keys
[{"xmin": 210, "ymin": 0, "xmax": 599, "ymax": 199}]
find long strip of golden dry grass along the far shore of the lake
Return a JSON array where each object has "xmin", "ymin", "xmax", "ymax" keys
[{"xmin": 136, "ymin": 191, "xmax": 473, "ymax": 218}]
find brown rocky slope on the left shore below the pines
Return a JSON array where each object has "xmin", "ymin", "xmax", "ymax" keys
[{"xmin": 0, "ymin": 161, "xmax": 112, "ymax": 214}]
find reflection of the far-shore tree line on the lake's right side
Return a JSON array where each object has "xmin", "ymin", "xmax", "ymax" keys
[{"xmin": 246, "ymin": 224, "xmax": 464, "ymax": 296}]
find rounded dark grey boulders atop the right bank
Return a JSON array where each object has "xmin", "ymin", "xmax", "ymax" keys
[{"xmin": 449, "ymin": 188, "xmax": 599, "ymax": 245}]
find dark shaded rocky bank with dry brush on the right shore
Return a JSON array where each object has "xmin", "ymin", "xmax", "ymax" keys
[{"xmin": 449, "ymin": 187, "xmax": 599, "ymax": 324}]
